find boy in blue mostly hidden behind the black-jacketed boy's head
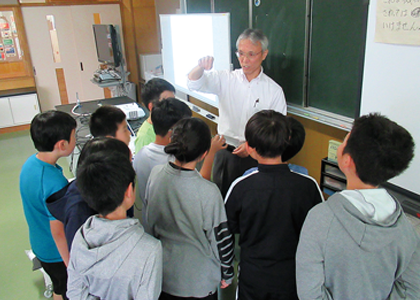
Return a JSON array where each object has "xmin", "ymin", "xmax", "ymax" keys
[{"xmin": 244, "ymin": 116, "xmax": 309, "ymax": 176}]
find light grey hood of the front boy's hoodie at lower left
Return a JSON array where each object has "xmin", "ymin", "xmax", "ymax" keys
[{"xmin": 72, "ymin": 215, "xmax": 144, "ymax": 277}]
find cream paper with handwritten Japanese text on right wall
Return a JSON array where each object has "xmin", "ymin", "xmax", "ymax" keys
[{"xmin": 375, "ymin": 0, "xmax": 420, "ymax": 45}]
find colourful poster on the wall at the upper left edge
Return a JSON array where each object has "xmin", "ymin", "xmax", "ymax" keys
[{"xmin": 0, "ymin": 11, "xmax": 22, "ymax": 62}]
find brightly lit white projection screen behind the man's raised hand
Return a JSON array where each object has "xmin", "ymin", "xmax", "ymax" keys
[{"xmin": 160, "ymin": 13, "xmax": 231, "ymax": 107}]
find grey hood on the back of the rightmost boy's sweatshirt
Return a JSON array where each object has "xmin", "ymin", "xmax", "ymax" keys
[{"xmin": 326, "ymin": 193, "xmax": 405, "ymax": 252}]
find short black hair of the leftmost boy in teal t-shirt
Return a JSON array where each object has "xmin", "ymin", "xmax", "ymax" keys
[{"xmin": 30, "ymin": 110, "xmax": 77, "ymax": 152}]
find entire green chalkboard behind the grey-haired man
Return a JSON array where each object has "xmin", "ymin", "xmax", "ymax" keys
[{"xmin": 187, "ymin": 0, "xmax": 368, "ymax": 118}]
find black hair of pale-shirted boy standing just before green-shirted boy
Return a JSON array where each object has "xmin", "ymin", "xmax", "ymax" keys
[{"xmin": 151, "ymin": 98, "xmax": 192, "ymax": 136}]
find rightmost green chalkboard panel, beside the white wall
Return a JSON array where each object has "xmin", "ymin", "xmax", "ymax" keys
[{"xmin": 308, "ymin": 0, "xmax": 368, "ymax": 118}]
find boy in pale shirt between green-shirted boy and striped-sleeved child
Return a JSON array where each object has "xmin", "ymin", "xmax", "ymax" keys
[{"xmin": 133, "ymin": 98, "xmax": 192, "ymax": 220}]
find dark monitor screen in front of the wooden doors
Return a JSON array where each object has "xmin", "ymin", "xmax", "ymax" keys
[{"xmin": 93, "ymin": 24, "xmax": 120, "ymax": 67}]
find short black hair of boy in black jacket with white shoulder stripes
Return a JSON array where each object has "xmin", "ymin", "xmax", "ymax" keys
[{"xmin": 245, "ymin": 110, "xmax": 290, "ymax": 158}]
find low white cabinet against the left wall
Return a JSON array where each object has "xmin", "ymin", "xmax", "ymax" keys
[{"xmin": 0, "ymin": 93, "xmax": 40, "ymax": 128}]
